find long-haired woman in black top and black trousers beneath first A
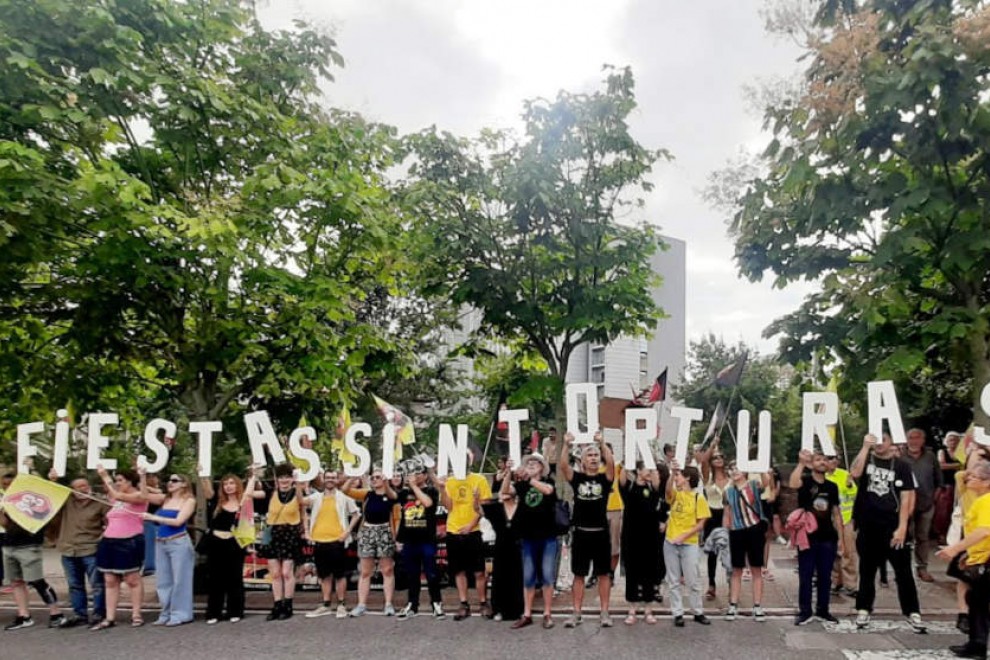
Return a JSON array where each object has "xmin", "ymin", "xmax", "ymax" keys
[{"xmin": 200, "ymin": 466, "xmax": 264, "ymax": 625}]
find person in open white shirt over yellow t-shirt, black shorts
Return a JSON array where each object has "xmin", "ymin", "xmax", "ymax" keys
[{"xmin": 305, "ymin": 470, "xmax": 361, "ymax": 619}]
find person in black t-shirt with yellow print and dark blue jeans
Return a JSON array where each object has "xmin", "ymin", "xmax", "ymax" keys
[{"xmin": 397, "ymin": 464, "xmax": 446, "ymax": 619}]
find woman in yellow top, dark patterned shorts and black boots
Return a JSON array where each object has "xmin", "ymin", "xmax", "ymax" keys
[{"xmin": 258, "ymin": 463, "xmax": 308, "ymax": 621}]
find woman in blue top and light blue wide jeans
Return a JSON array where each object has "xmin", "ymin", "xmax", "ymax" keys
[{"xmin": 144, "ymin": 474, "xmax": 196, "ymax": 627}]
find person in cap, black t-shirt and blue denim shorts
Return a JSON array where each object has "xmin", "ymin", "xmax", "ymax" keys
[{"xmin": 501, "ymin": 454, "xmax": 557, "ymax": 629}]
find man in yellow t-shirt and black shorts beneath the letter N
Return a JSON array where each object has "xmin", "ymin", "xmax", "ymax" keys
[{"xmin": 437, "ymin": 452, "xmax": 494, "ymax": 621}]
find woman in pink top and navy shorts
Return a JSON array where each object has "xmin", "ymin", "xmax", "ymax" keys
[{"xmin": 91, "ymin": 466, "xmax": 148, "ymax": 630}]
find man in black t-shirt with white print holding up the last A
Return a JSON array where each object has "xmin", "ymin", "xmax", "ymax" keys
[{"xmin": 849, "ymin": 433, "xmax": 927, "ymax": 633}]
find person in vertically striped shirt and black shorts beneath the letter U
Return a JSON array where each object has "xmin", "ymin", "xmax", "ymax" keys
[{"xmin": 722, "ymin": 461, "xmax": 769, "ymax": 621}]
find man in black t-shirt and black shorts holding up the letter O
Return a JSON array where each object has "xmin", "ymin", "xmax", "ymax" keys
[{"xmin": 560, "ymin": 432, "xmax": 615, "ymax": 628}]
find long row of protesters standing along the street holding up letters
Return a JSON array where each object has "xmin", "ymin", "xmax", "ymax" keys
[{"xmin": 0, "ymin": 429, "xmax": 990, "ymax": 657}]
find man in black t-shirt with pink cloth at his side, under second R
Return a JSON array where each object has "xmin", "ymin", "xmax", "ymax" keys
[{"xmin": 788, "ymin": 449, "xmax": 844, "ymax": 626}]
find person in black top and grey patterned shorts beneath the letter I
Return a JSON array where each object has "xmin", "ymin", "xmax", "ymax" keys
[{"xmin": 341, "ymin": 467, "xmax": 398, "ymax": 617}]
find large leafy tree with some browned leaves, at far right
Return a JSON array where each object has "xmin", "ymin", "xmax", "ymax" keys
[{"xmin": 716, "ymin": 0, "xmax": 990, "ymax": 424}]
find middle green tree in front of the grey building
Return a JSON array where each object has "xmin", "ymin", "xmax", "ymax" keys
[{"xmin": 407, "ymin": 69, "xmax": 668, "ymax": 408}]
